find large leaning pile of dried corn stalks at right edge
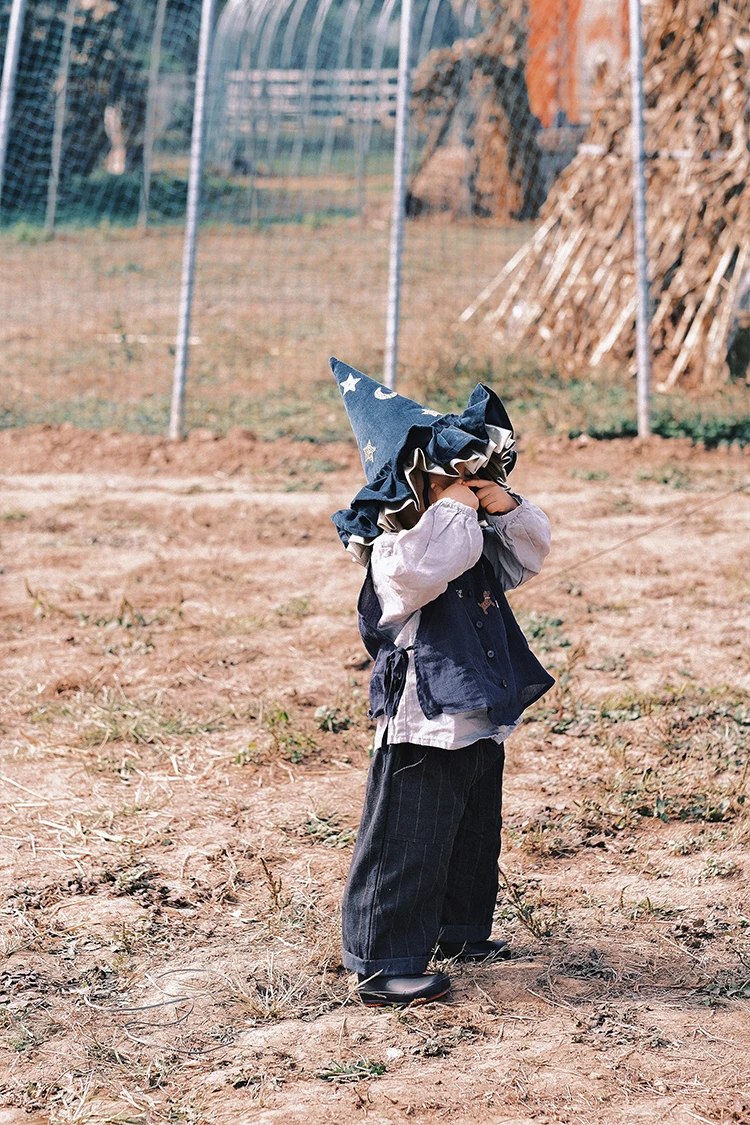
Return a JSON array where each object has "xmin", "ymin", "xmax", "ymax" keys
[{"xmin": 462, "ymin": 0, "xmax": 750, "ymax": 389}]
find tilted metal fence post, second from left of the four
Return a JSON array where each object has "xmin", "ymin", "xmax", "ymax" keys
[{"xmin": 169, "ymin": 0, "xmax": 215, "ymax": 441}]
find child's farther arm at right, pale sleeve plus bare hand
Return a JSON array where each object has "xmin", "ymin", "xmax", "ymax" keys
[{"xmin": 470, "ymin": 480, "xmax": 550, "ymax": 590}]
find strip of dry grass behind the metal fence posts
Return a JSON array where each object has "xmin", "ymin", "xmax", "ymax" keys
[{"xmin": 0, "ymin": 216, "xmax": 750, "ymax": 450}]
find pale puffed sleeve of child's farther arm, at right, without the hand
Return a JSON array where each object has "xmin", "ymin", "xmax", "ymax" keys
[{"xmin": 484, "ymin": 493, "xmax": 550, "ymax": 590}]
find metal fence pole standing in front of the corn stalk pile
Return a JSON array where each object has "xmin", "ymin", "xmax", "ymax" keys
[{"xmin": 629, "ymin": 0, "xmax": 651, "ymax": 438}]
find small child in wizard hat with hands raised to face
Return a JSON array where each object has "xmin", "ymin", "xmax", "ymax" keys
[{"xmin": 331, "ymin": 359, "xmax": 553, "ymax": 1006}]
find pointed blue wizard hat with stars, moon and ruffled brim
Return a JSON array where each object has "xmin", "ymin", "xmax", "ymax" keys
[{"xmin": 331, "ymin": 358, "xmax": 516, "ymax": 558}]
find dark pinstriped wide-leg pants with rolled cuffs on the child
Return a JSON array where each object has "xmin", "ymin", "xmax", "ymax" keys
[{"xmin": 342, "ymin": 739, "xmax": 505, "ymax": 977}]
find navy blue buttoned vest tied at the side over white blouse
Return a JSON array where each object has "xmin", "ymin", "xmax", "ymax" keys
[{"xmin": 358, "ymin": 546, "xmax": 554, "ymax": 727}]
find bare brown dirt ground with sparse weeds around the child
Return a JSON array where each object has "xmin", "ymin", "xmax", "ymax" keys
[{"xmin": 0, "ymin": 428, "xmax": 750, "ymax": 1125}]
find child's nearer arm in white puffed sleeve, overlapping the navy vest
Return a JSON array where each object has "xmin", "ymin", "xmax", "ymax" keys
[{"xmin": 370, "ymin": 493, "xmax": 485, "ymax": 627}]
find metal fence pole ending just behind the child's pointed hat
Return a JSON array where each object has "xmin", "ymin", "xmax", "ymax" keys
[{"xmin": 383, "ymin": 0, "xmax": 412, "ymax": 390}]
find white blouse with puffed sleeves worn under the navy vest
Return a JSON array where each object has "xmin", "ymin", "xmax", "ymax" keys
[{"xmin": 370, "ymin": 494, "xmax": 550, "ymax": 750}]
